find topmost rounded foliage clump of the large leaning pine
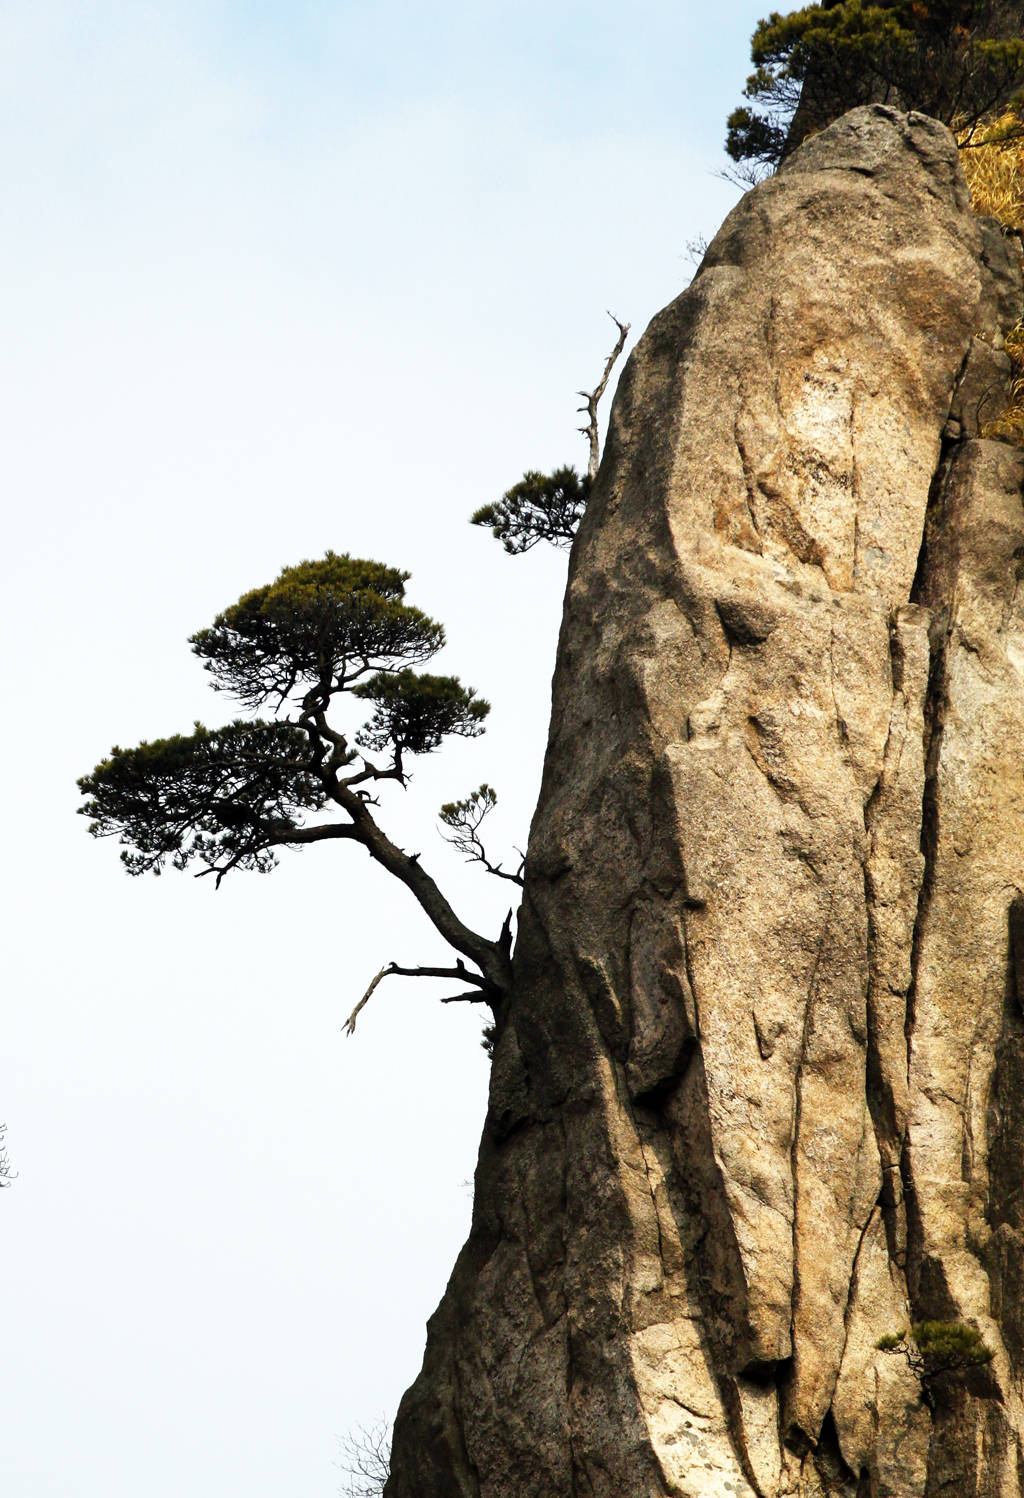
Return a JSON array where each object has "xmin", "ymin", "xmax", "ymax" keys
[{"xmin": 190, "ymin": 551, "xmax": 445, "ymax": 710}]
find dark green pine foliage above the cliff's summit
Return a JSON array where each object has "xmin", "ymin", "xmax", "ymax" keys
[{"xmin": 726, "ymin": 0, "xmax": 1024, "ymax": 166}]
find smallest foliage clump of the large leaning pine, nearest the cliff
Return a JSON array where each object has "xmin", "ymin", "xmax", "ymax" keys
[{"xmin": 353, "ymin": 671, "xmax": 491, "ymax": 753}]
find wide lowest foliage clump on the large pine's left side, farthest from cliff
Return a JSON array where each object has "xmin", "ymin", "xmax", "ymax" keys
[{"xmin": 78, "ymin": 719, "xmax": 325, "ymax": 873}]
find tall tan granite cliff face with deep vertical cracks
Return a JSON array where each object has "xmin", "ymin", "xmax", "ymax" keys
[{"xmin": 386, "ymin": 106, "xmax": 1024, "ymax": 1498}]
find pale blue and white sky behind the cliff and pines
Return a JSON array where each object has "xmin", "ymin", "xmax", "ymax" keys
[{"xmin": 0, "ymin": 0, "xmax": 759, "ymax": 1498}]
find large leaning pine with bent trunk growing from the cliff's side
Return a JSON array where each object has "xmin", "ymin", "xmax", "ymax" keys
[{"xmin": 78, "ymin": 551, "xmax": 511, "ymax": 1005}]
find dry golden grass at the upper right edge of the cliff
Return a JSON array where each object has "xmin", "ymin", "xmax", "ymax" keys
[{"xmin": 958, "ymin": 115, "xmax": 1024, "ymax": 448}]
